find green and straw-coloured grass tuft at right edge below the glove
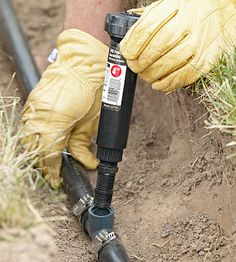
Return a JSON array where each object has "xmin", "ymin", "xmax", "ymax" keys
[{"xmin": 196, "ymin": 49, "xmax": 236, "ymax": 157}]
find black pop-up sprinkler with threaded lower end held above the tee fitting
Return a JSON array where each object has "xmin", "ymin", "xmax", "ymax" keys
[{"xmin": 94, "ymin": 13, "xmax": 138, "ymax": 209}]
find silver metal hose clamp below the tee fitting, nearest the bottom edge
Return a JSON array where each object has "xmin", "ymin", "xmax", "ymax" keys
[{"xmin": 88, "ymin": 229, "xmax": 117, "ymax": 259}]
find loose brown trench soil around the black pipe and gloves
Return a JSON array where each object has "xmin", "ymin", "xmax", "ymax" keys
[{"xmin": 0, "ymin": 0, "xmax": 236, "ymax": 262}]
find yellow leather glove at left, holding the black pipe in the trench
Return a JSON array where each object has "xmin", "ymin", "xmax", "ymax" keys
[{"xmin": 21, "ymin": 29, "xmax": 108, "ymax": 188}]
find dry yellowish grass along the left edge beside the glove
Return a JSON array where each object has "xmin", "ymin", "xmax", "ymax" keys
[{"xmin": 0, "ymin": 86, "xmax": 45, "ymax": 228}]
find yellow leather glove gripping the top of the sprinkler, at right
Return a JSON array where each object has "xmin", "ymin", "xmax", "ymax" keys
[{"xmin": 121, "ymin": 0, "xmax": 236, "ymax": 92}]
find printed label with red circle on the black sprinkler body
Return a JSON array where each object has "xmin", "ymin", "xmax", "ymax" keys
[{"xmin": 102, "ymin": 44, "xmax": 127, "ymax": 111}]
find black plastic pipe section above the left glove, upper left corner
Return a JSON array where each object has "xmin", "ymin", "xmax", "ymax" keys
[{"xmin": 0, "ymin": 0, "xmax": 40, "ymax": 97}]
